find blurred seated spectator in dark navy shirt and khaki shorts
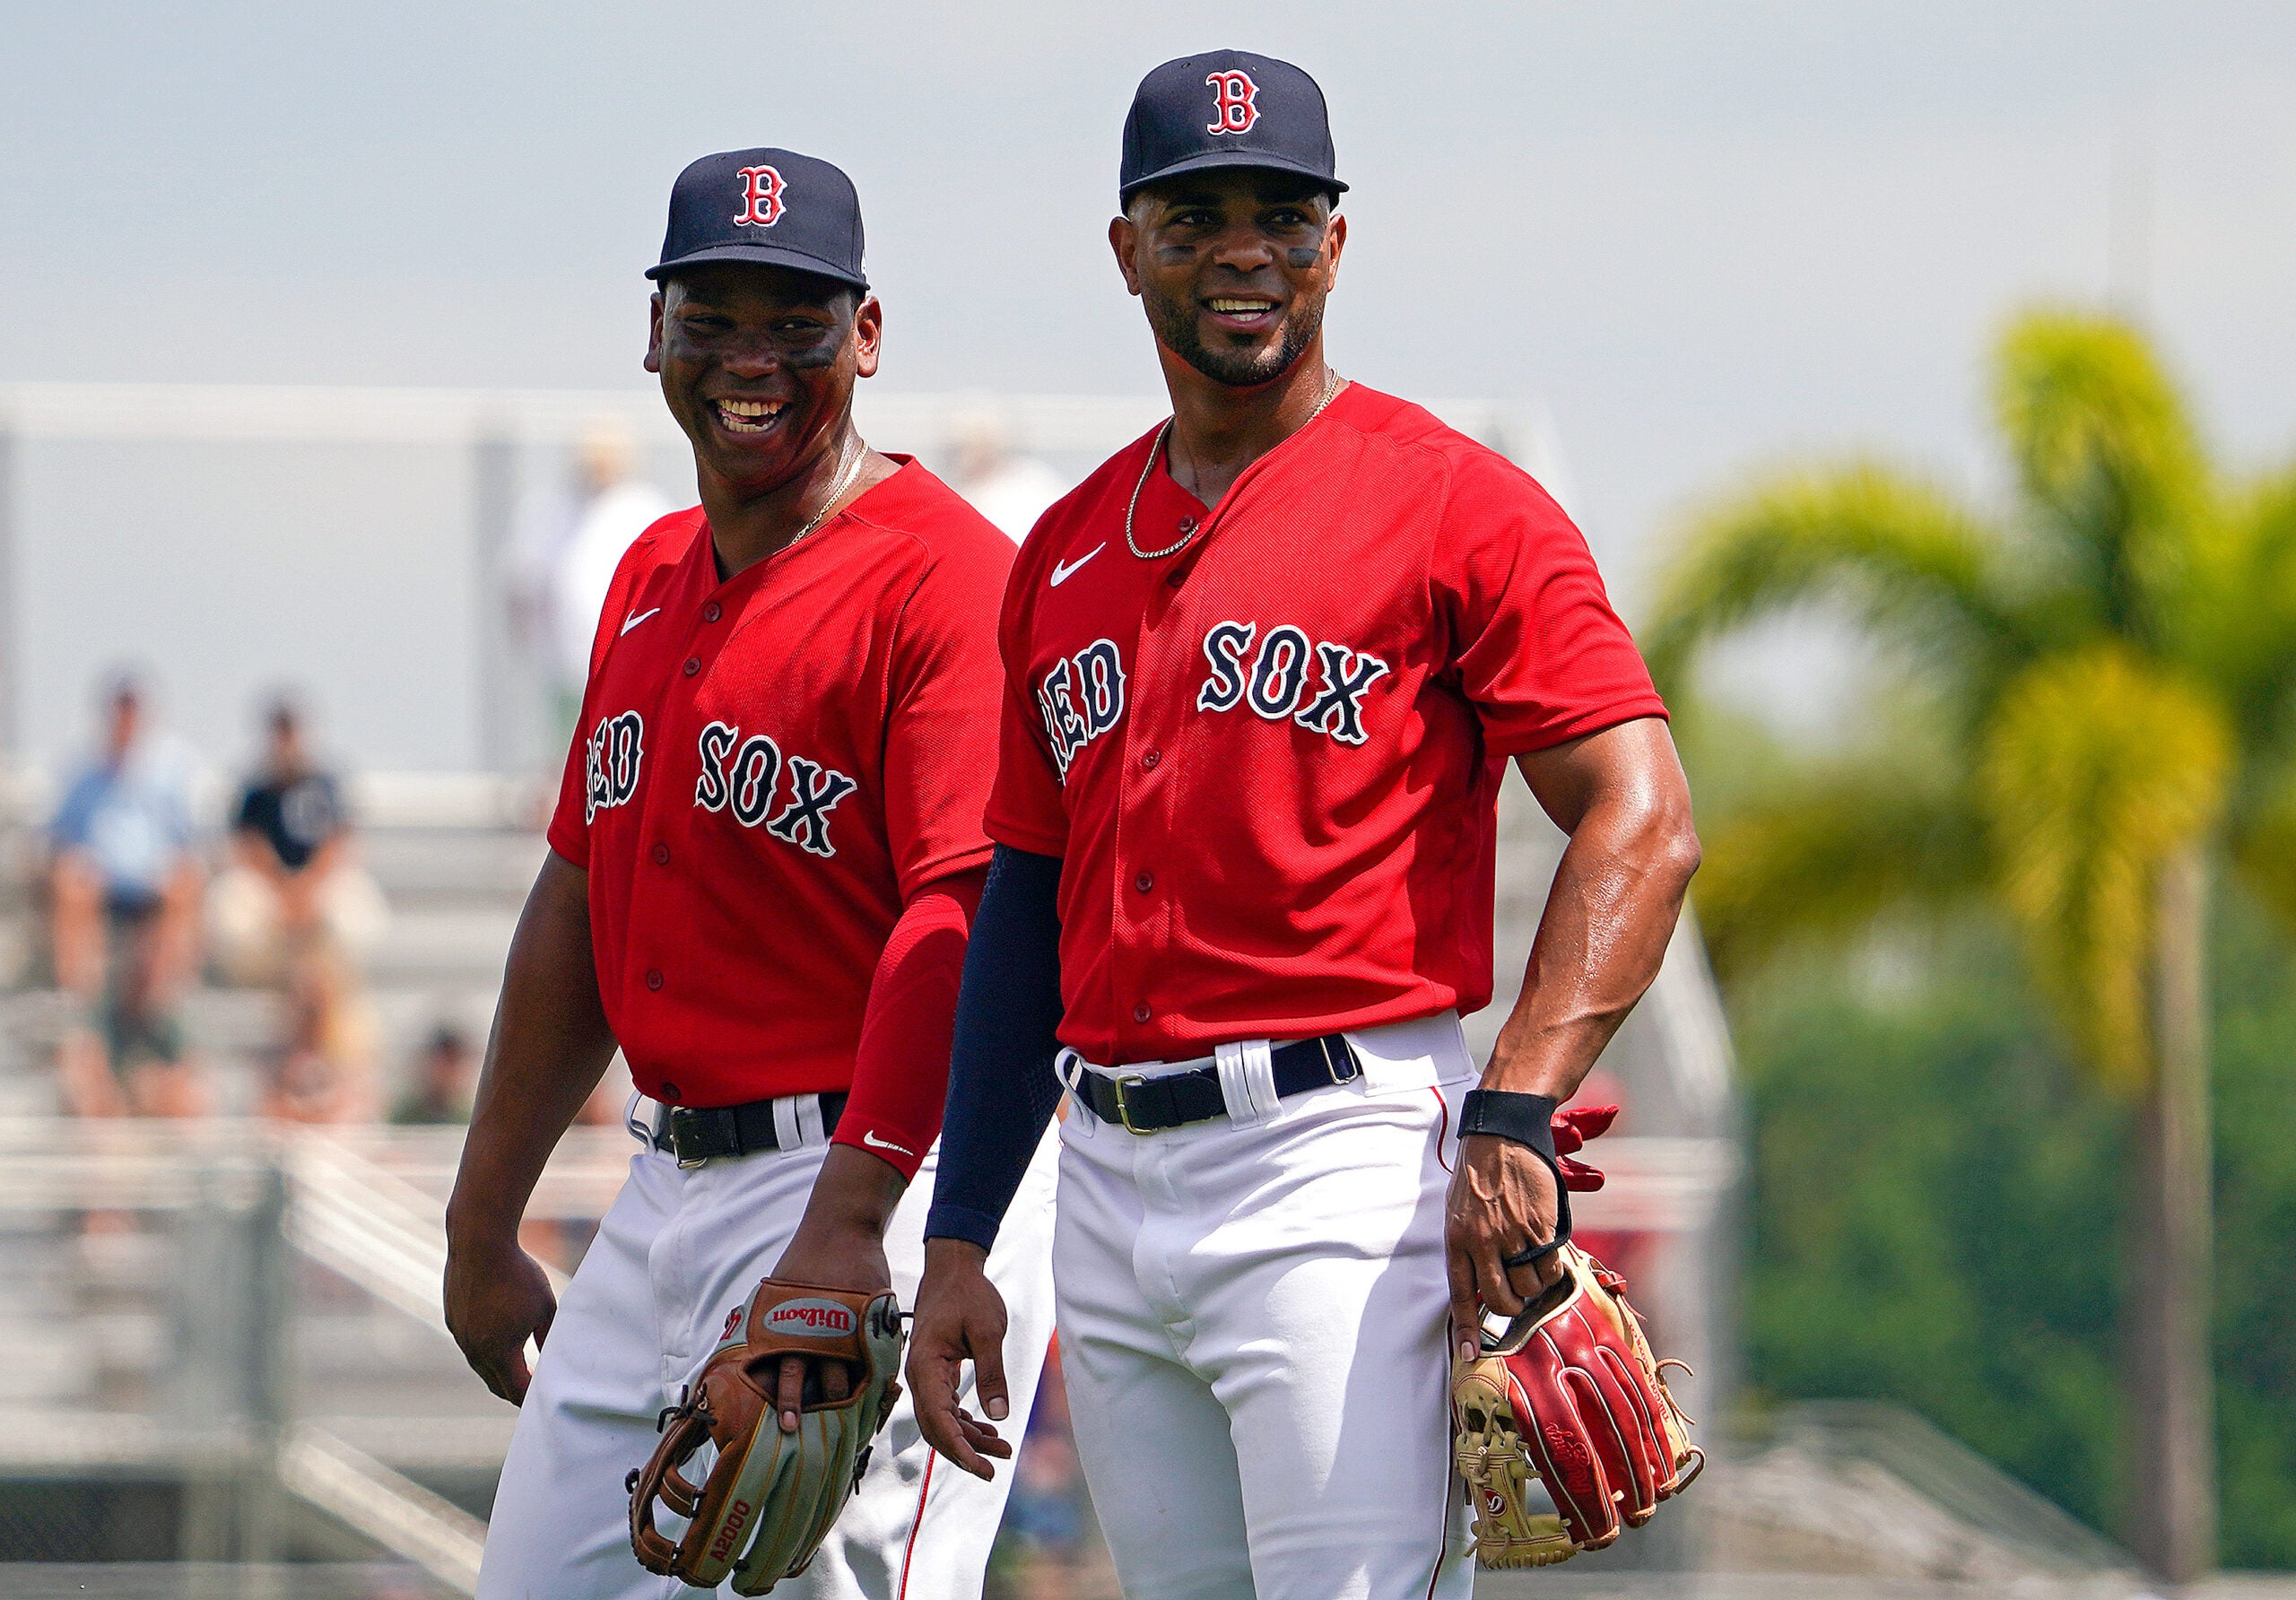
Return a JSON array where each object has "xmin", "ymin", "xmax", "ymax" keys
[{"xmin": 206, "ymin": 700, "xmax": 390, "ymax": 1123}]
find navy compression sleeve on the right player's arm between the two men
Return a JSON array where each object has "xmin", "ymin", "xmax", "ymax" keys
[{"xmin": 926, "ymin": 845, "xmax": 1061, "ymax": 1248}]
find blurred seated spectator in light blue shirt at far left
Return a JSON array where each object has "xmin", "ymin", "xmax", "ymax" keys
[{"xmin": 48, "ymin": 677, "xmax": 206, "ymax": 1116}]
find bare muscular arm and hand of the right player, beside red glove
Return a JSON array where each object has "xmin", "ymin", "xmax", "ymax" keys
[{"xmin": 1447, "ymin": 717, "xmax": 1699, "ymax": 1354}]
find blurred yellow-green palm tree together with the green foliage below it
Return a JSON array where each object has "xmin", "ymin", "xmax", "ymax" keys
[{"xmin": 1644, "ymin": 310, "xmax": 2296, "ymax": 1577}]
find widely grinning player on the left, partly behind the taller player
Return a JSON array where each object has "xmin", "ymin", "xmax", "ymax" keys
[{"xmin": 446, "ymin": 149, "xmax": 1051, "ymax": 1600}]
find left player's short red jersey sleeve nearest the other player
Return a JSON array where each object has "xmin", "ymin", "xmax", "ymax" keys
[{"xmin": 884, "ymin": 524, "xmax": 1013, "ymax": 898}]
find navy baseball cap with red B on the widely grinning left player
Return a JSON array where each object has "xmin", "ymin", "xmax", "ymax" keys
[{"xmin": 645, "ymin": 149, "xmax": 868, "ymax": 290}]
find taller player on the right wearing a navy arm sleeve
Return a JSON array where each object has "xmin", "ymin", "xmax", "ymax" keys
[{"xmin": 907, "ymin": 50, "xmax": 1697, "ymax": 1600}]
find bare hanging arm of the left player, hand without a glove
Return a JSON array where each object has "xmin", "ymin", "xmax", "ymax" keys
[{"xmin": 446, "ymin": 854, "xmax": 613, "ymax": 1403}]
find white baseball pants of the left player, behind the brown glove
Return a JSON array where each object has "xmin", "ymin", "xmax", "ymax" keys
[{"xmin": 477, "ymin": 1097, "xmax": 1057, "ymax": 1600}]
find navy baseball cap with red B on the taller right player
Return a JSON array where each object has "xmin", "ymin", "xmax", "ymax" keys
[{"xmin": 1116, "ymin": 50, "xmax": 1348, "ymax": 204}]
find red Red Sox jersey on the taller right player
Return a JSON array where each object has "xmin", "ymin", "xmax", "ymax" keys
[{"xmin": 987, "ymin": 386, "xmax": 1665, "ymax": 1065}]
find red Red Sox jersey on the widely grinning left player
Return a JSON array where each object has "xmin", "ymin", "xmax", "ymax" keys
[{"xmin": 549, "ymin": 457, "xmax": 1013, "ymax": 1110}]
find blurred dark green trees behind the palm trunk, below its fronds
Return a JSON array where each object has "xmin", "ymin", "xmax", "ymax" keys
[{"xmin": 1726, "ymin": 863, "xmax": 2296, "ymax": 1568}]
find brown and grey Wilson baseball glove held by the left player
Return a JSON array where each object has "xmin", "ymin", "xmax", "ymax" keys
[{"xmin": 624, "ymin": 1279, "xmax": 902, "ymax": 1596}]
